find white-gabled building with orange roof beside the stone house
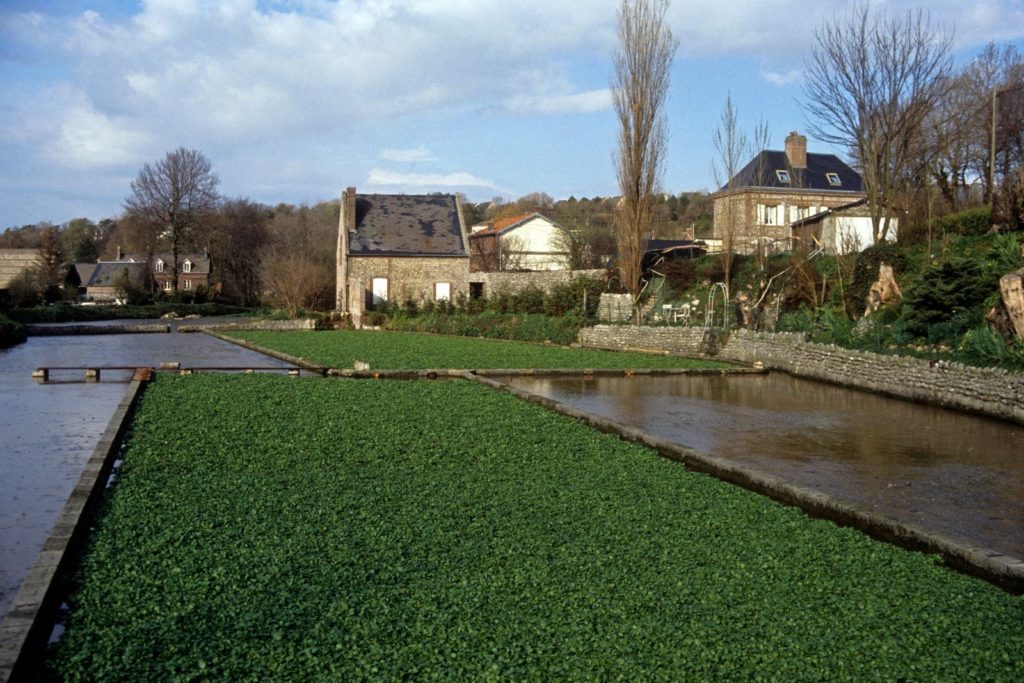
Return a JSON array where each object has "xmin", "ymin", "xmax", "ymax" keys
[{"xmin": 469, "ymin": 213, "xmax": 568, "ymax": 272}]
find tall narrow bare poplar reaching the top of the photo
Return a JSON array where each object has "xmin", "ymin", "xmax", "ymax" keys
[{"xmin": 612, "ymin": 0, "xmax": 679, "ymax": 322}]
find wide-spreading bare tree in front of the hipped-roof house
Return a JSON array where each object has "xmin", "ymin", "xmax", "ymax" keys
[{"xmin": 804, "ymin": 2, "xmax": 952, "ymax": 242}]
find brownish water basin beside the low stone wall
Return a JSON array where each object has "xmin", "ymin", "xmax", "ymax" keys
[{"xmin": 510, "ymin": 373, "xmax": 1024, "ymax": 557}]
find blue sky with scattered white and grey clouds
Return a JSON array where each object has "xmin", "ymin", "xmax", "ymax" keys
[{"xmin": 0, "ymin": 0, "xmax": 1024, "ymax": 229}]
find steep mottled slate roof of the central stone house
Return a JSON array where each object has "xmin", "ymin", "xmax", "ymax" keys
[{"xmin": 348, "ymin": 195, "xmax": 469, "ymax": 257}]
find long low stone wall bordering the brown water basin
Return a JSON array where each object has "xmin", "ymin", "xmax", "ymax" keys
[{"xmin": 580, "ymin": 325, "xmax": 1024, "ymax": 424}]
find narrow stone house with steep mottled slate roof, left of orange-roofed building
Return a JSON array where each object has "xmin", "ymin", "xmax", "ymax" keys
[{"xmin": 335, "ymin": 187, "xmax": 469, "ymax": 326}]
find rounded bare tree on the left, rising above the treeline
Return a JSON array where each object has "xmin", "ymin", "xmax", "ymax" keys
[{"xmin": 125, "ymin": 147, "xmax": 220, "ymax": 293}]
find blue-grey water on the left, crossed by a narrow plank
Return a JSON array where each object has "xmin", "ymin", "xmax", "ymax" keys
[{"xmin": 0, "ymin": 333, "xmax": 289, "ymax": 615}]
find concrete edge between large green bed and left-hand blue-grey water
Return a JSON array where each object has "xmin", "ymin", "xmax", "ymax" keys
[{"xmin": 0, "ymin": 379, "xmax": 147, "ymax": 683}]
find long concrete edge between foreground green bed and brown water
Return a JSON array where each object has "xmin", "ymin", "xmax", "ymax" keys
[{"xmin": 464, "ymin": 373, "xmax": 1024, "ymax": 594}]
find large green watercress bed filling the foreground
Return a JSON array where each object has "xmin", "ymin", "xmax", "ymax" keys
[{"xmin": 49, "ymin": 376, "xmax": 1024, "ymax": 681}]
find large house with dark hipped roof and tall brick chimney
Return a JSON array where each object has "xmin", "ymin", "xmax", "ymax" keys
[{"xmin": 712, "ymin": 131, "xmax": 868, "ymax": 254}]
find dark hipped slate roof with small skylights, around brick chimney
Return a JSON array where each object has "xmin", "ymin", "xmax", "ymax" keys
[{"xmin": 718, "ymin": 150, "xmax": 864, "ymax": 193}]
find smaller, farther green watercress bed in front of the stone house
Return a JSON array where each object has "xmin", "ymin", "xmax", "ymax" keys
[{"xmin": 230, "ymin": 330, "xmax": 730, "ymax": 370}]
